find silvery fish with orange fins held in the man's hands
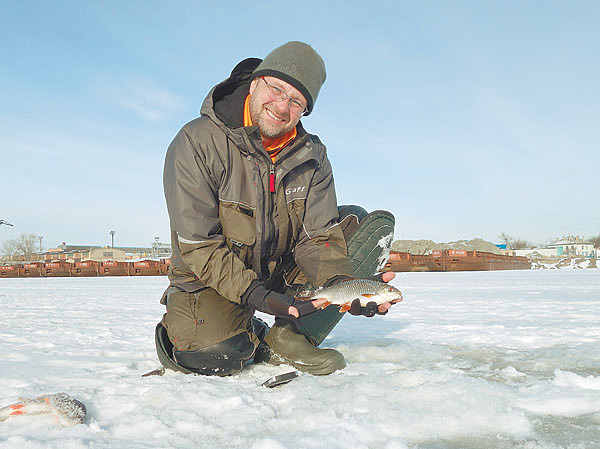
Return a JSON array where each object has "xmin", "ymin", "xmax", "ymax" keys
[{"xmin": 296, "ymin": 279, "xmax": 402, "ymax": 313}]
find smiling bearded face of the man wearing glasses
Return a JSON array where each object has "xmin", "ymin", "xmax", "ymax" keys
[{"xmin": 250, "ymin": 76, "xmax": 306, "ymax": 139}]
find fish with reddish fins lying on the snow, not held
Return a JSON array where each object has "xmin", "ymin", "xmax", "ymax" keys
[{"xmin": 0, "ymin": 393, "xmax": 87, "ymax": 426}]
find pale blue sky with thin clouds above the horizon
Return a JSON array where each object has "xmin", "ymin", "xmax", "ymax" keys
[{"xmin": 0, "ymin": 1, "xmax": 600, "ymax": 247}]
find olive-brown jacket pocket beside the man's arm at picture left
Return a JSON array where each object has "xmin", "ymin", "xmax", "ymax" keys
[{"xmin": 219, "ymin": 200, "xmax": 256, "ymax": 267}]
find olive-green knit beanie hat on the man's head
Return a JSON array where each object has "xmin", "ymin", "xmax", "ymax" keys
[{"xmin": 252, "ymin": 41, "xmax": 327, "ymax": 115}]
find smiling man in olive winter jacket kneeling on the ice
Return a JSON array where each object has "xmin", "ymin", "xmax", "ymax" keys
[{"xmin": 156, "ymin": 42, "xmax": 400, "ymax": 375}]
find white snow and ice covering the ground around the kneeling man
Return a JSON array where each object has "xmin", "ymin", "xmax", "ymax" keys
[{"xmin": 0, "ymin": 269, "xmax": 600, "ymax": 449}]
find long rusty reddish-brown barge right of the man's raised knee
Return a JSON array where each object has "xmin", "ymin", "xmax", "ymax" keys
[{"xmin": 384, "ymin": 249, "xmax": 531, "ymax": 272}]
